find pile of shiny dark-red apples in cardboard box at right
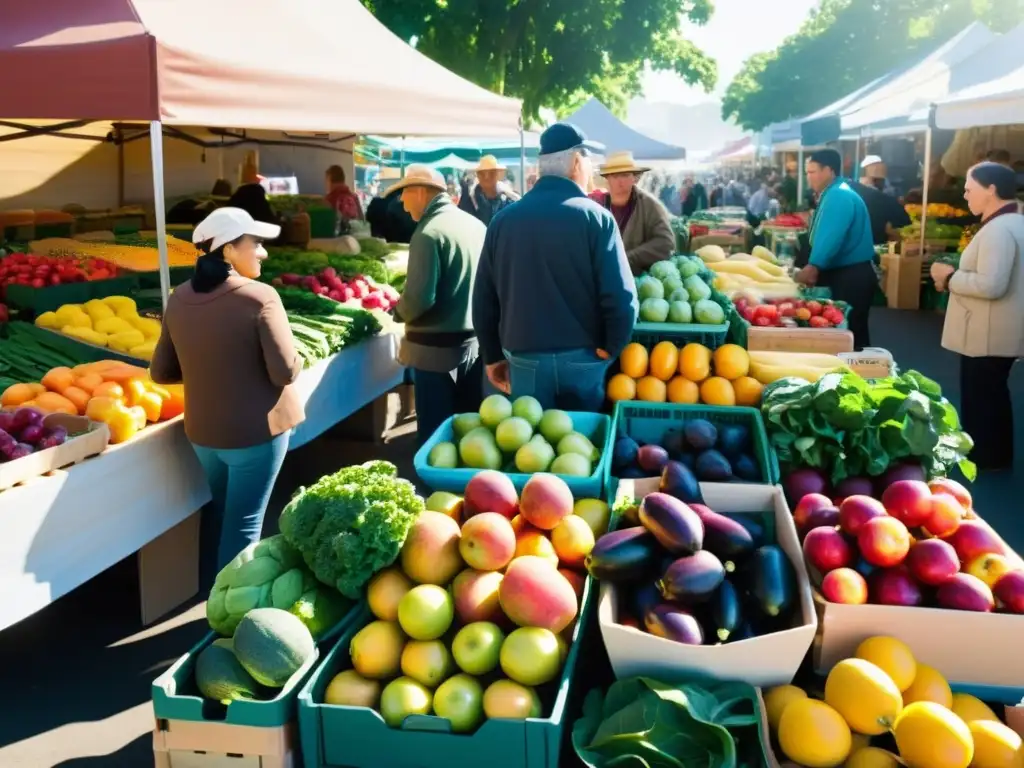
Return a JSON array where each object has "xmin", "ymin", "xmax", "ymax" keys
[{"xmin": 793, "ymin": 478, "xmax": 1024, "ymax": 613}]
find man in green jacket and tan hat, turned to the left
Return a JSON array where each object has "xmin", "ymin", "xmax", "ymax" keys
[{"xmin": 388, "ymin": 165, "xmax": 487, "ymax": 445}]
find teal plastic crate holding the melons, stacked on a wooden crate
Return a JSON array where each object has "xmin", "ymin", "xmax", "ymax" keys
[{"xmin": 151, "ymin": 603, "xmax": 366, "ymax": 728}]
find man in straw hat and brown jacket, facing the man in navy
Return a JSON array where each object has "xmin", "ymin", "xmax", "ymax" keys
[{"xmin": 593, "ymin": 152, "xmax": 676, "ymax": 274}]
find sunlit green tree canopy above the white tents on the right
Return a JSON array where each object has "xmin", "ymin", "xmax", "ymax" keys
[{"xmin": 722, "ymin": 0, "xmax": 1024, "ymax": 130}]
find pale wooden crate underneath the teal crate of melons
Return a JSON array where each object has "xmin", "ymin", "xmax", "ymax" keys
[{"xmin": 153, "ymin": 719, "xmax": 302, "ymax": 768}]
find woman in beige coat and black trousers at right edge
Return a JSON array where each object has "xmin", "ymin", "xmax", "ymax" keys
[{"xmin": 932, "ymin": 163, "xmax": 1024, "ymax": 470}]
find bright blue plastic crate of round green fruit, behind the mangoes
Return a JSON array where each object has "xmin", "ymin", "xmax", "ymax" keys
[{"xmin": 413, "ymin": 411, "xmax": 612, "ymax": 499}]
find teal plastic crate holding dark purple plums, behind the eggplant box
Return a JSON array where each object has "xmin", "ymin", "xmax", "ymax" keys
[{"xmin": 605, "ymin": 400, "xmax": 780, "ymax": 487}]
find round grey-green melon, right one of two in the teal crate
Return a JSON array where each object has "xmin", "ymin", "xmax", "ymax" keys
[{"xmin": 234, "ymin": 608, "xmax": 316, "ymax": 688}]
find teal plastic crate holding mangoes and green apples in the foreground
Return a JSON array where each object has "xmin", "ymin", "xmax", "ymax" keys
[{"xmin": 299, "ymin": 578, "xmax": 598, "ymax": 768}]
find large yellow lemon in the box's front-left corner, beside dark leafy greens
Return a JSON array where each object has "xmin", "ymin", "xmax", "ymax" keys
[{"xmin": 778, "ymin": 698, "xmax": 851, "ymax": 768}]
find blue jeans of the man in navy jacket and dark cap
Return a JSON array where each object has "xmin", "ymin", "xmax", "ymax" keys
[{"xmin": 505, "ymin": 349, "xmax": 610, "ymax": 413}]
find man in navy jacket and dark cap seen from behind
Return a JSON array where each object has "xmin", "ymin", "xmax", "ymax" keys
[{"xmin": 473, "ymin": 123, "xmax": 638, "ymax": 411}]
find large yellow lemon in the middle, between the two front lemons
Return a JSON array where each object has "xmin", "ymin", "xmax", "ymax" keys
[{"xmin": 825, "ymin": 658, "xmax": 903, "ymax": 736}]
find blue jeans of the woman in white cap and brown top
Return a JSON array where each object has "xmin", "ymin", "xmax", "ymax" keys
[{"xmin": 193, "ymin": 432, "xmax": 290, "ymax": 581}]
